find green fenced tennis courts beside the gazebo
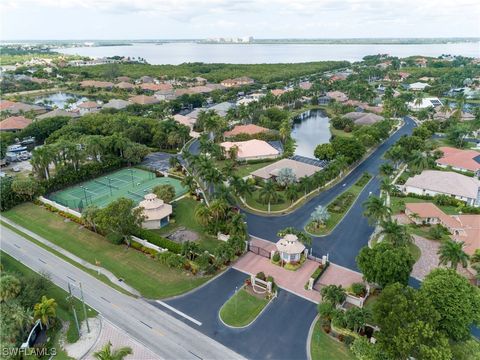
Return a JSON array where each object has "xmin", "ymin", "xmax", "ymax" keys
[{"xmin": 48, "ymin": 169, "xmax": 187, "ymax": 211}]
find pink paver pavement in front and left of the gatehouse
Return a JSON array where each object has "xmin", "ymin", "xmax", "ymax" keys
[{"xmin": 233, "ymin": 252, "xmax": 320, "ymax": 304}]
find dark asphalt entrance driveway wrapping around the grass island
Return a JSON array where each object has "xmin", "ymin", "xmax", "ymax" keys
[{"xmin": 156, "ymin": 269, "xmax": 317, "ymax": 360}]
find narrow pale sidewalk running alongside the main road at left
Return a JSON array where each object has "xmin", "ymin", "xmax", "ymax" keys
[{"xmin": 0, "ymin": 215, "xmax": 141, "ymax": 296}]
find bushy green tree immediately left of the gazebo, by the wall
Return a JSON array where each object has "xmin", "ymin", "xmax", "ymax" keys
[{"xmin": 95, "ymin": 198, "xmax": 145, "ymax": 245}]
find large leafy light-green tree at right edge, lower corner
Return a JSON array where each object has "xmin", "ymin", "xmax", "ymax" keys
[{"xmin": 420, "ymin": 269, "xmax": 480, "ymax": 341}]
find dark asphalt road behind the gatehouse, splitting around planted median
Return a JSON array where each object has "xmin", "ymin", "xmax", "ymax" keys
[{"xmin": 245, "ymin": 117, "xmax": 415, "ymax": 270}]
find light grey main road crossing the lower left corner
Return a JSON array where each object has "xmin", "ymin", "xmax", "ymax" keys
[{"xmin": 0, "ymin": 225, "xmax": 242, "ymax": 360}]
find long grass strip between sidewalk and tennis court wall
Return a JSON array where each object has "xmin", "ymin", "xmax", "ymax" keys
[{"xmin": 3, "ymin": 203, "xmax": 210, "ymax": 298}]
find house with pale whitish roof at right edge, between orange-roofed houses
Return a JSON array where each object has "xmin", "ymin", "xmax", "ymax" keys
[{"xmin": 402, "ymin": 170, "xmax": 480, "ymax": 207}]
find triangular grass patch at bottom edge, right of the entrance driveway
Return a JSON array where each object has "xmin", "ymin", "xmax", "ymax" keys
[{"xmin": 310, "ymin": 321, "xmax": 355, "ymax": 360}]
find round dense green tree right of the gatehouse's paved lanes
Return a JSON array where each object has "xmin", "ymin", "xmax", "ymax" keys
[{"xmin": 356, "ymin": 241, "xmax": 415, "ymax": 287}]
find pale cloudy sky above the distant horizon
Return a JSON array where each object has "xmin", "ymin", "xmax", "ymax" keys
[{"xmin": 0, "ymin": 0, "xmax": 480, "ymax": 40}]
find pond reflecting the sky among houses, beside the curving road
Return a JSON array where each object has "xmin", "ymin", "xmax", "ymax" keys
[{"xmin": 292, "ymin": 110, "xmax": 331, "ymax": 158}]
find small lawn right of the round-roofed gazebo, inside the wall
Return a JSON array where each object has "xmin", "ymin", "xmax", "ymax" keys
[{"xmin": 152, "ymin": 198, "xmax": 221, "ymax": 252}]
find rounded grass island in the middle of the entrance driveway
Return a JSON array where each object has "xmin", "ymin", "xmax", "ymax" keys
[{"xmin": 220, "ymin": 289, "xmax": 268, "ymax": 327}]
